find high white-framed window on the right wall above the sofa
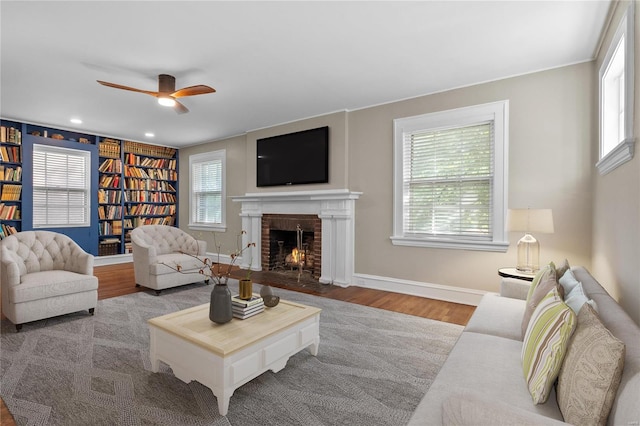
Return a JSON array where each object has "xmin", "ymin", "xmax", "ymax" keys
[{"xmin": 596, "ymin": 2, "xmax": 634, "ymax": 175}]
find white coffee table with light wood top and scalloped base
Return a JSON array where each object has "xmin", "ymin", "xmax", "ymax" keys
[{"xmin": 148, "ymin": 300, "xmax": 321, "ymax": 416}]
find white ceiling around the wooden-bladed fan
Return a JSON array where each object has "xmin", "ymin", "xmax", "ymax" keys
[{"xmin": 0, "ymin": 0, "xmax": 610, "ymax": 147}]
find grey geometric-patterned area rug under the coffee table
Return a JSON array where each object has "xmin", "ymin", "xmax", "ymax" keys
[{"xmin": 0, "ymin": 281, "xmax": 462, "ymax": 426}]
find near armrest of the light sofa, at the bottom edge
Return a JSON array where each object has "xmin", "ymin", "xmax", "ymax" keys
[{"xmin": 442, "ymin": 391, "xmax": 566, "ymax": 426}]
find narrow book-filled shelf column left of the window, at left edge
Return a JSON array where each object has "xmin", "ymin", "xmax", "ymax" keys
[{"xmin": 0, "ymin": 120, "xmax": 22, "ymax": 239}]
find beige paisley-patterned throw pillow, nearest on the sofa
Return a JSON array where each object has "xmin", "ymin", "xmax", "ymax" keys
[{"xmin": 556, "ymin": 304, "xmax": 625, "ymax": 425}]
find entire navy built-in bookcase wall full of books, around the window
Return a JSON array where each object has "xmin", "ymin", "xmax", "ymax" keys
[{"xmin": 0, "ymin": 119, "xmax": 178, "ymax": 255}]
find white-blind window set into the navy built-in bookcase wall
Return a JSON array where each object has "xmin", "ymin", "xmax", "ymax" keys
[{"xmin": 33, "ymin": 144, "xmax": 91, "ymax": 228}]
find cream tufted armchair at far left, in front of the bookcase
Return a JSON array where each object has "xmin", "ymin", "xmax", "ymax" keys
[{"xmin": 0, "ymin": 231, "xmax": 98, "ymax": 331}]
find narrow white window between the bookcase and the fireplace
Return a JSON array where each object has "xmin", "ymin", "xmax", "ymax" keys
[{"xmin": 189, "ymin": 150, "xmax": 226, "ymax": 230}]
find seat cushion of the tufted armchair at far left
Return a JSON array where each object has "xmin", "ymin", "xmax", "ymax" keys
[{"xmin": 9, "ymin": 271, "xmax": 98, "ymax": 303}]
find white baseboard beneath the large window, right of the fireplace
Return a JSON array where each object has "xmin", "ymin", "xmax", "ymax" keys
[{"xmin": 352, "ymin": 274, "xmax": 486, "ymax": 306}]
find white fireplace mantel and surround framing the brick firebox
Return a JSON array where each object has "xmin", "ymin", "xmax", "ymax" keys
[{"xmin": 231, "ymin": 189, "xmax": 362, "ymax": 287}]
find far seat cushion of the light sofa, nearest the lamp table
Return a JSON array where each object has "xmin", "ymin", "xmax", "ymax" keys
[{"xmin": 465, "ymin": 293, "xmax": 525, "ymax": 341}]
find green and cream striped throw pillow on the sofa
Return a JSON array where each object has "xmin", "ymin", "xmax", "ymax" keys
[{"xmin": 522, "ymin": 288, "xmax": 576, "ymax": 404}]
